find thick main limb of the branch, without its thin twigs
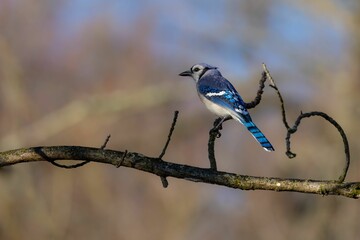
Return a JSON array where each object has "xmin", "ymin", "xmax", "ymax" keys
[{"xmin": 0, "ymin": 146, "xmax": 360, "ymax": 198}]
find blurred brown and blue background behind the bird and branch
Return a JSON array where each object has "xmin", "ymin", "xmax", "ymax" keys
[{"xmin": 0, "ymin": 0, "xmax": 360, "ymax": 240}]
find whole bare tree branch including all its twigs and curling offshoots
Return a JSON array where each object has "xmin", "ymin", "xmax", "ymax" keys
[{"xmin": 0, "ymin": 64, "xmax": 354, "ymax": 198}]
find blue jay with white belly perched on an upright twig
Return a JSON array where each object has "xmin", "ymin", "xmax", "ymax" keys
[{"xmin": 179, "ymin": 63, "xmax": 275, "ymax": 152}]
